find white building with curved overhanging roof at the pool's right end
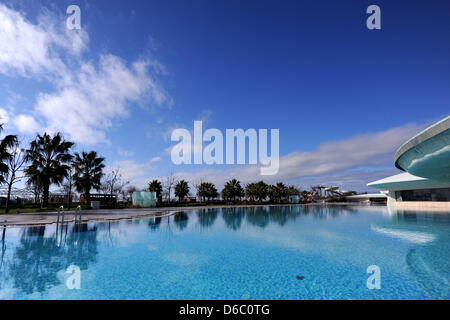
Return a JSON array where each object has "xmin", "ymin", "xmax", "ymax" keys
[{"xmin": 367, "ymin": 116, "xmax": 450, "ymax": 212}]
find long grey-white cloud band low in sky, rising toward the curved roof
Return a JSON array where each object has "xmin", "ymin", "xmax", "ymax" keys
[{"xmin": 167, "ymin": 120, "xmax": 426, "ymax": 188}]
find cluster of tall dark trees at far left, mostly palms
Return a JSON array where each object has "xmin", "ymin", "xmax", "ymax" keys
[{"xmin": 0, "ymin": 125, "xmax": 105, "ymax": 212}]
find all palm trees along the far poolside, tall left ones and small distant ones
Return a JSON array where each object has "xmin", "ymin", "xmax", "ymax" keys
[{"xmin": 0, "ymin": 125, "xmax": 300, "ymax": 212}]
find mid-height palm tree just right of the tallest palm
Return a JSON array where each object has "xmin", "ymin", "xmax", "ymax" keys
[{"xmin": 73, "ymin": 151, "xmax": 105, "ymax": 203}]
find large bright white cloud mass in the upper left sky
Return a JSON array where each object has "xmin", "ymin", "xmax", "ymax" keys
[{"xmin": 0, "ymin": 4, "xmax": 173, "ymax": 144}]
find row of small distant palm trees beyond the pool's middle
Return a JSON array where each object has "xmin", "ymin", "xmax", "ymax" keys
[{"xmin": 148, "ymin": 179, "xmax": 301, "ymax": 203}]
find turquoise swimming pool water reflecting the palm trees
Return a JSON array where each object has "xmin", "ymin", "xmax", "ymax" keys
[{"xmin": 0, "ymin": 206, "xmax": 450, "ymax": 299}]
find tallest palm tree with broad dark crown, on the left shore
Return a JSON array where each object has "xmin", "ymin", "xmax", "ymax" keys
[{"xmin": 25, "ymin": 132, "xmax": 74, "ymax": 207}]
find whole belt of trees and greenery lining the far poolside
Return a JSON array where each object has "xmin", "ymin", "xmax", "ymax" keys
[{"xmin": 0, "ymin": 129, "xmax": 358, "ymax": 215}]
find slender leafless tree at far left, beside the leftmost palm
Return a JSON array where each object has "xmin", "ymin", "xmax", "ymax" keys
[{"xmin": 5, "ymin": 140, "xmax": 26, "ymax": 213}]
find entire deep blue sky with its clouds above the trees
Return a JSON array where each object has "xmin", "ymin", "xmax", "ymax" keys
[{"xmin": 0, "ymin": 0, "xmax": 450, "ymax": 191}]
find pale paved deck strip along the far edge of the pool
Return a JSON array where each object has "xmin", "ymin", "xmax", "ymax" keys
[{"xmin": 0, "ymin": 203, "xmax": 384, "ymax": 228}]
